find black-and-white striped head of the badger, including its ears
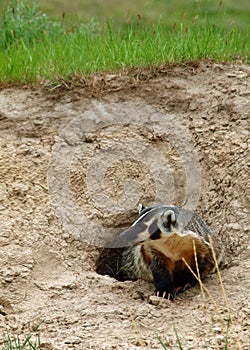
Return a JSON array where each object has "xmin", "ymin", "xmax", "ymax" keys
[{"xmin": 121, "ymin": 204, "xmax": 179, "ymax": 243}]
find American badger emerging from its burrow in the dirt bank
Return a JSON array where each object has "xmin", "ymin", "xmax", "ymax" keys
[{"xmin": 97, "ymin": 205, "xmax": 223, "ymax": 300}]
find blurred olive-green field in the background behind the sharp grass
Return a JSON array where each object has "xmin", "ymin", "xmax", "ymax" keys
[{"xmin": 0, "ymin": 0, "xmax": 250, "ymax": 25}]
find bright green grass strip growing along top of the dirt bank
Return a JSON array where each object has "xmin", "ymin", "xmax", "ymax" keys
[{"xmin": 0, "ymin": 0, "xmax": 250, "ymax": 82}]
